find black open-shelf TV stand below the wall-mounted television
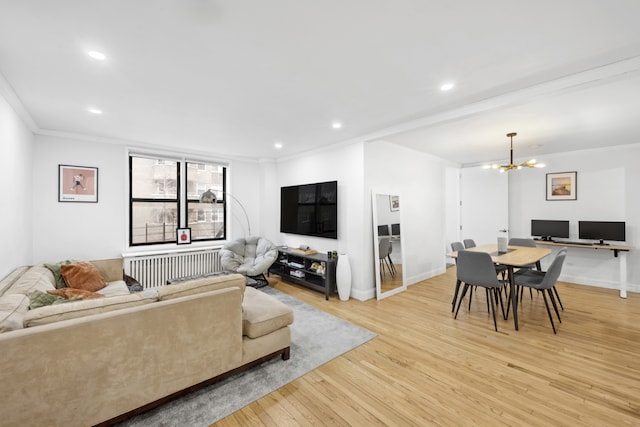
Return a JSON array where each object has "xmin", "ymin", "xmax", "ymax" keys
[{"xmin": 268, "ymin": 247, "xmax": 336, "ymax": 300}]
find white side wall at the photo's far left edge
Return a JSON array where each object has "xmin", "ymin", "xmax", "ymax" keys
[{"xmin": 0, "ymin": 92, "xmax": 36, "ymax": 278}]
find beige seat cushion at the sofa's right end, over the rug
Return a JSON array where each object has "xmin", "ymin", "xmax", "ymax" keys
[{"xmin": 242, "ymin": 287, "xmax": 293, "ymax": 338}]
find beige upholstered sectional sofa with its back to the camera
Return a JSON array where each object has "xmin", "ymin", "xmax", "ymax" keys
[{"xmin": 0, "ymin": 259, "xmax": 293, "ymax": 426}]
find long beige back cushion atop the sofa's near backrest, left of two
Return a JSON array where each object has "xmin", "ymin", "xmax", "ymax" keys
[{"xmin": 24, "ymin": 294, "xmax": 157, "ymax": 328}]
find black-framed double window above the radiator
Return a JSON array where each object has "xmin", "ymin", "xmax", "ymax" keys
[{"xmin": 129, "ymin": 154, "xmax": 226, "ymax": 246}]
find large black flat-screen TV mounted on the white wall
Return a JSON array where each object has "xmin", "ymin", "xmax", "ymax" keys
[{"xmin": 280, "ymin": 181, "xmax": 338, "ymax": 239}]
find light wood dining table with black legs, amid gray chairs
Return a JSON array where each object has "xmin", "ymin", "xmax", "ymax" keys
[{"xmin": 447, "ymin": 244, "xmax": 551, "ymax": 331}]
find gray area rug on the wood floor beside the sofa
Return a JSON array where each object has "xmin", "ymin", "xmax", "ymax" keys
[{"xmin": 119, "ymin": 287, "xmax": 376, "ymax": 427}]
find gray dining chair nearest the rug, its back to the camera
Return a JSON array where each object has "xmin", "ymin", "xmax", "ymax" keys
[{"xmin": 454, "ymin": 251, "xmax": 506, "ymax": 331}]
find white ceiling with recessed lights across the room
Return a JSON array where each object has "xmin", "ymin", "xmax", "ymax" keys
[{"xmin": 0, "ymin": 0, "xmax": 640, "ymax": 164}]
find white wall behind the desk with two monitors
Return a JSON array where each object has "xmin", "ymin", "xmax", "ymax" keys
[{"xmin": 509, "ymin": 145, "xmax": 640, "ymax": 292}]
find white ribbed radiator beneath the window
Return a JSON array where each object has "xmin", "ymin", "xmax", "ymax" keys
[{"xmin": 124, "ymin": 249, "xmax": 222, "ymax": 289}]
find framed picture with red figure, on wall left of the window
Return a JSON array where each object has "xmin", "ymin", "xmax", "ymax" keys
[{"xmin": 58, "ymin": 165, "xmax": 98, "ymax": 203}]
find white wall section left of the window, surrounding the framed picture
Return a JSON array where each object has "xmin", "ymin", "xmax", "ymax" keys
[{"xmin": 33, "ymin": 136, "xmax": 128, "ymax": 263}]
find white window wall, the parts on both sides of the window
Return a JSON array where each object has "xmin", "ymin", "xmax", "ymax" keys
[{"xmin": 27, "ymin": 136, "xmax": 262, "ymax": 263}]
